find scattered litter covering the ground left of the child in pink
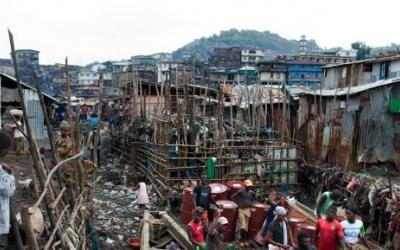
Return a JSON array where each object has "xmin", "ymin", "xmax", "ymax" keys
[{"xmin": 93, "ymin": 158, "xmax": 161, "ymax": 249}]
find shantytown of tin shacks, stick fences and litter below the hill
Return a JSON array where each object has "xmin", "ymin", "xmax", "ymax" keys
[{"xmin": 0, "ymin": 39, "xmax": 400, "ymax": 250}]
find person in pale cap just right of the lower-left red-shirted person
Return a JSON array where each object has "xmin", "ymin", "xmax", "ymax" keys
[{"xmin": 206, "ymin": 216, "xmax": 229, "ymax": 250}]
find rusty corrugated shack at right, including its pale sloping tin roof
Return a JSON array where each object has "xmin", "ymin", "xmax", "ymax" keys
[{"xmin": 299, "ymin": 77, "xmax": 400, "ymax": 172}]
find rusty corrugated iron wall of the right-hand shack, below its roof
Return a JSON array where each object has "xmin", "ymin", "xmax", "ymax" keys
[{"xmin": 307, "ymin": 84, "xmax": 400, "ymax": 169}]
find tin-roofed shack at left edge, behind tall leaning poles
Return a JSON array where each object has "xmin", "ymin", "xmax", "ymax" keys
[{"xmin": 0, "ymin": 73, "xmax": 57, "ymax": 149}]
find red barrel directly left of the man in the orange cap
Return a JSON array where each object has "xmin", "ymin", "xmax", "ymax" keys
[{"xmin": 216, "ymin": 200, "xmax": 238, "ymax": 242}]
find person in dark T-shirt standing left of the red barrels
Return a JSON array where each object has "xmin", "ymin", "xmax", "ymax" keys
[{"xmin": 192, "ymin": 175, "xmax": 216, "ymax": 226}]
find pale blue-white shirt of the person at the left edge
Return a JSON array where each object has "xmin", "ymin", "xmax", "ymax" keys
[{"xmin": 0, "ymin": 165, "xmax": 15, "ymax": 234}]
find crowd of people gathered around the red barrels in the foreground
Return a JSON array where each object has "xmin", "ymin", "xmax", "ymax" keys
[{"xmin": 182, "ymin": 176, "xmax": 371, "ymax": 250}]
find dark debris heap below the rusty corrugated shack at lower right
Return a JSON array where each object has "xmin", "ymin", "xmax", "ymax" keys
[{"xmin": 298, "ymin": 166, "xmax": 400, "ymax": 247}]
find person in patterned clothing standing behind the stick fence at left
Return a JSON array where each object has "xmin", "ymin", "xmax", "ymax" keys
[{"xmin": 56, "ymin": 121, "xmax": 73, "ymax": 187}]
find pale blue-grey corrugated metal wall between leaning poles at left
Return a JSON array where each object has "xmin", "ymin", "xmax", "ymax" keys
[{"xmin": 24, "ymin": 89, "xmax": 50, "ymax": 149}]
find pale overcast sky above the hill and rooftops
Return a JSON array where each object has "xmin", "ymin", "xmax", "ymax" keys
[{"xmin": 0, "ymin": 0, "xmax": 400, "ymax": 64}]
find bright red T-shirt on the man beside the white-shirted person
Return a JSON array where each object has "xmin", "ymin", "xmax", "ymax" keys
[{"xmin": 316, "ymin": 219, "xmax": 343, "ymax": 250}]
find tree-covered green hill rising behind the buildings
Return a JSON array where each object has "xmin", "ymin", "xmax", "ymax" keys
[{"xmin": 173, "ymin": 29, "xmax": 319, "ymax": 61}]
